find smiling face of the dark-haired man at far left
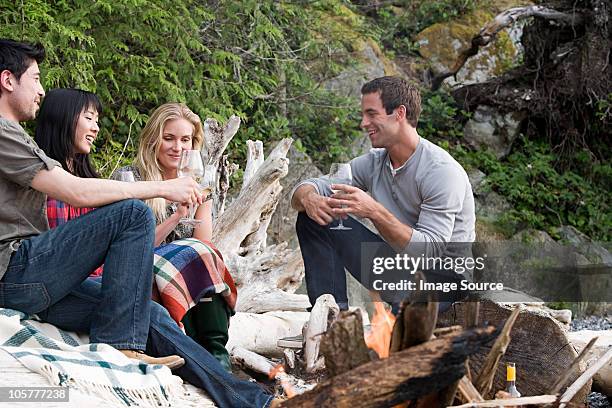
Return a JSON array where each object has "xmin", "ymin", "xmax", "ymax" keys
[{"xmin": 2, "ymin": 61, "xmax": 45, "ymax": 122}]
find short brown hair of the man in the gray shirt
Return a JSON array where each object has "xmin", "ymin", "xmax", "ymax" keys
[{"xmin": 361, "ymin": 76, "xmax": 421, "ymax": 127}]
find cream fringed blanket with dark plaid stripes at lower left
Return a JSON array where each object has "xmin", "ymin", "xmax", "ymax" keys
[{"xmin": 0, "ymin": 308, "xmax": 183, "ymax": 407}]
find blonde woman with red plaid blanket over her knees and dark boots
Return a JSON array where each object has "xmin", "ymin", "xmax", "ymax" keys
[{"xmin": 114, "ymin": 103, "xmax": 236, "ymax": 370}]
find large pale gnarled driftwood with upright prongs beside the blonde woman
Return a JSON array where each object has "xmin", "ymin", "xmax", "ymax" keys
[{"xmin": 202, "ymin": 116, "xmax": 310, "ymax": 313}]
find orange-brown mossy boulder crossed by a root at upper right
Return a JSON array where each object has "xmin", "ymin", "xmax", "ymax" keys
[{"xmin": 416, "ymin": 2, "xmax": 522, "ymax": 87}]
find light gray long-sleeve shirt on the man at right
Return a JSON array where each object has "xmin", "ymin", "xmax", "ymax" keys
[{"xmin": 294, "ymin": 138, "xmax": 476, "ymax": 257}]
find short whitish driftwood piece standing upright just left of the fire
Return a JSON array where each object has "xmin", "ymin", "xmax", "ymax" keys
[{"xmin": 304, "ymin": 294, "xmax": 340, "ymax": 373}]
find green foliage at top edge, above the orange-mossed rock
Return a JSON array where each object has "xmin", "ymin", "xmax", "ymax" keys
[{"xmin": 370, "ymin": 0, "xmax": 486, "ymax": 54}]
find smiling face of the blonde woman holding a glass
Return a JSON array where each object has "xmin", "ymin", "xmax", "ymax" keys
[{"xmin": 157, "ymin": 118, "xmax": 194, "ymax": 177}]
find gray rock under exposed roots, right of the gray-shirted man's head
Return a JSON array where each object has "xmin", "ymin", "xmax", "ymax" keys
[{"xmin": 463, "ymin": 106, "xmax": 526, "ymax": 159}]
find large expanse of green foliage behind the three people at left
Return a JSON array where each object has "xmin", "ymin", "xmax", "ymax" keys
[{"xmin": 0, "ymin": 0, "xmax": 362, "ymax": 175}]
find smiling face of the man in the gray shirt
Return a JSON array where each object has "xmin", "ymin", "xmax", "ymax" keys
[{"xmin": 360, "ymin": 92, "xmax": 399, "ymax": 148}]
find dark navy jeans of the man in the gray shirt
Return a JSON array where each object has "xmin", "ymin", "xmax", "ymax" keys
[{"xmin": 296, "ymin": 212, "xmax": 463, "ymax": 312}]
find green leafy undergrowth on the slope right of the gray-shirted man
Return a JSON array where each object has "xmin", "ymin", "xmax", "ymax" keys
[{"xmin": 453, "ymin": 137, "xmax": 612, "ymax": 241}]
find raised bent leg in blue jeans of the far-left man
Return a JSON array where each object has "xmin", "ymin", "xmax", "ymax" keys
[{"xmin": 0, "ymin": 200, "xmax": 155, "ymax": 350}]
